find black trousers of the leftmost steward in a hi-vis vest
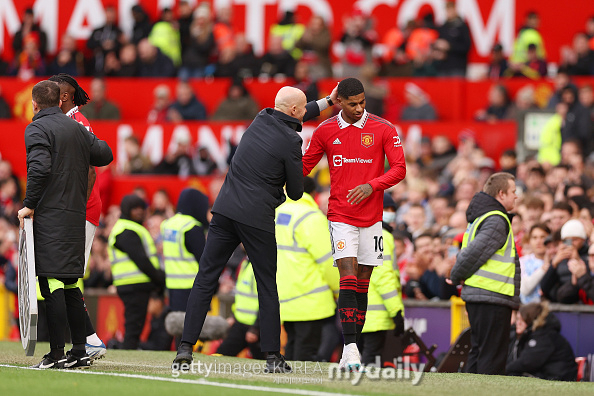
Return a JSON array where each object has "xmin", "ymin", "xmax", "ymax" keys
[{"xmin": 117, "ymin": 282, "xmax": 155, "ymax": 349}]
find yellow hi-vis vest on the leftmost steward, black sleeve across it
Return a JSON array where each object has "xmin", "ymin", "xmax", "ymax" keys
[{"xmin": 107, "ymin": 219, "xmax": 159, "ymax": 286}]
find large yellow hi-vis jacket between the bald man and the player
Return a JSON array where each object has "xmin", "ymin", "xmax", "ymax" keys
[{"xmin": 276, "ymin": 194, "xmax": 339, "ymax": 322}]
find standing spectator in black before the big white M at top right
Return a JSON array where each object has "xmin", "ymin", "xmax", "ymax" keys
[{"xmin": 438, "ymin": 1, "xmax": 471, "ymax": 77}]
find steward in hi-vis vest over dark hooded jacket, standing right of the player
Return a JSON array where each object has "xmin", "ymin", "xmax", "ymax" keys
[{"xmin": 450, "ymin": 172, "xmax": 520, "ymax": 375}]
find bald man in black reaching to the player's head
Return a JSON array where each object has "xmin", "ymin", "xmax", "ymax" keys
[{"xmin": 173, "ymin": 87, "xmax": 336, "ymax": 372}]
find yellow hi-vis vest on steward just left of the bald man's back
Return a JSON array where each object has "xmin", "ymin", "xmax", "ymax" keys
[{"xmin": 161, "ymin": 213, "xmax": 202, "ymax": 289}]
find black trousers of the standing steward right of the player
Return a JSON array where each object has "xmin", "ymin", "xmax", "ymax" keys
[{"xmin": 466, "ymin": 303, "xmax": 512, "ymax": 375}]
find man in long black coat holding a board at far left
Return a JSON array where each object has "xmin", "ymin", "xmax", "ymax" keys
[{"xmin": 18, "ymin": 81, "xmax": 113, "ymax": 368}]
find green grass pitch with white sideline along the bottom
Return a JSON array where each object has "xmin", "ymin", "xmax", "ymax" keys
[{"xmin": 0, "ymin": 342, "xmax": 594, "ymax": 396}]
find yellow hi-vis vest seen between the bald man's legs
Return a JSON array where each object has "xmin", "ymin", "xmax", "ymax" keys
[{"xmin": 231, "ymin": 260, "xmax": 259, "ymax": 326}]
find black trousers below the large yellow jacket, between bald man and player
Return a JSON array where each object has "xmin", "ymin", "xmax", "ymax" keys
[{"xmin": 284, "ymin": 319, "xmax": 326, "ymax": 362}]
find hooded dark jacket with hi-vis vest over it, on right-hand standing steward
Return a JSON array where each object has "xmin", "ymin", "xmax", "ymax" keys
[{"xmin": 450, "ymin": 192, "xmax": 520, "ymax": 309}]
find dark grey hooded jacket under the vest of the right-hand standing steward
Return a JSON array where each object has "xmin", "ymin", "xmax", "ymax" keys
[{"xmin": 450, "ymin": 192, "xmax": 520, "ymax": 309}]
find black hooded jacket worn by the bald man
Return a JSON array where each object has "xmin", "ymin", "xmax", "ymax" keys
[{"xmin": 212, "ymin": 102, "xmax": 320, "ymax": 233}]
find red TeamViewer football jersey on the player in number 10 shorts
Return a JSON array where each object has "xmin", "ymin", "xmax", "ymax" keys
[{"xmin": 303, "ymin": 111, "xmax": 406, "ymax": 227}]
